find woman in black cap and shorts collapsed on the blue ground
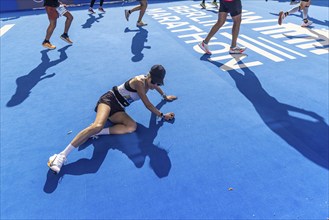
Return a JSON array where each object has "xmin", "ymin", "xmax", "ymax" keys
[{"xmin": 48, "ymin": 65, "xmax": 177, "ymax": 173}]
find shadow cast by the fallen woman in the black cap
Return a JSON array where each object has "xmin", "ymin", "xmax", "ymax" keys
[{"xmin": 43, "ymin": 100, "xmax": 174, "ymax": 193}]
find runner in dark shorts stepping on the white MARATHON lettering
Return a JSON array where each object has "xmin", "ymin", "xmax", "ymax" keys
[{"xmin": 198, "ymin": 0, "xmax": 246, "ymax": 54}]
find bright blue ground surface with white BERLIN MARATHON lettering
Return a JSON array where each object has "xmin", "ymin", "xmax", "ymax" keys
[{"xmin": 0, "ymin": 0, "xmax": 329, "ymax": 219}]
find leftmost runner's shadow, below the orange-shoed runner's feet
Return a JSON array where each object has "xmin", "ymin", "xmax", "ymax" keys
[{"xmin": 7, "ymin": 45, "xmax": 72, "ymax": 107}]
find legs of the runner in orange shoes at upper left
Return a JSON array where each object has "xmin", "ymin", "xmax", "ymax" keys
[{"xmin": 42, "ymin": 0, "xmax": 73, "ymax": 50}]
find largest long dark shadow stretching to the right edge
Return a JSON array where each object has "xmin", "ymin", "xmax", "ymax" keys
[{"xmin": 202, "ymin": 55, "xmax": 329, "ymax": 169}]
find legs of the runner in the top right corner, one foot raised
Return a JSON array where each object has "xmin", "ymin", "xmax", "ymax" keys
[{"xmin": 278, "ymin": 0, "xmax": 313, "ymax": 27}]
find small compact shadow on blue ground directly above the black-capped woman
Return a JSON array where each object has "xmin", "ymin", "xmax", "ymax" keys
[{"xmin": 125, "ymin": 27, "xmax": 151, "ymax": 62}]
